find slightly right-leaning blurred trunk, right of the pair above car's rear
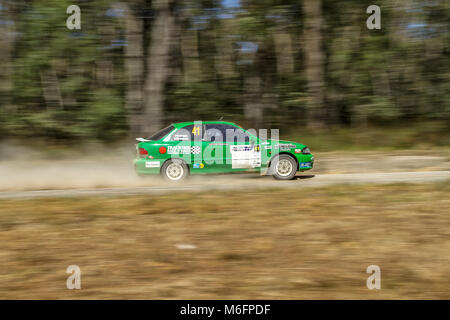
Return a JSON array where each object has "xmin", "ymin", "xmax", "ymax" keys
[{"xmin": 142, "ymin": 0, "xmax": 175, "ymax": 134}]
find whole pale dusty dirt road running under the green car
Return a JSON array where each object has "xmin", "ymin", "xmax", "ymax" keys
[{"xmin": 0, "ymin": 149, "xmax": 450, "ymax": 199}]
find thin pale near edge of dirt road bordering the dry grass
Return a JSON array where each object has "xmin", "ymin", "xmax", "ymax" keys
[{"xmin": 0, "ymin": 171, "xmax": 450, "ymax": 199}]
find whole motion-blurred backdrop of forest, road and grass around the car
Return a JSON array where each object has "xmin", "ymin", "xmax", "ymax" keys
[{"xmin": 0, "ymin": 0, "xmax": 450, "ymax": 299}]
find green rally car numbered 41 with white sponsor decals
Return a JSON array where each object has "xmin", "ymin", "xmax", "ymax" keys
[{"xmin": 134, "ymin": 121, "xmax": 314, "ymax": 181}]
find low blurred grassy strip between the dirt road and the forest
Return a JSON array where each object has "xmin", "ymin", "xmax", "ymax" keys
[{"xmin": 0, "ymin": 121, "xmax": 450, "ymax": 161}]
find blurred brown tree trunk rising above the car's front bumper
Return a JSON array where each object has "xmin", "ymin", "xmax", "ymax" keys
[{"xmin": 303, "ymin": 0, "xmax": 325, "ymax": 128}]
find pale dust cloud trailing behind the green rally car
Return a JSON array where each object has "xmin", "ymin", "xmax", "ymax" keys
[{"xmin": 0, "ymin": 142, "xmax": 162, "ymax": 191}]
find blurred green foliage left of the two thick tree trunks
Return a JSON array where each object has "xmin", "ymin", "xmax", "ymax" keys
[{"xmin": 7, "ymin": 0, "xmax": 126, "ymax": 139}]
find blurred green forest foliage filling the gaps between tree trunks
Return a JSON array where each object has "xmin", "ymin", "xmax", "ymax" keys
[{"xmin": 0, "ymin": 0, "xmax": 450, "ymax": 139}]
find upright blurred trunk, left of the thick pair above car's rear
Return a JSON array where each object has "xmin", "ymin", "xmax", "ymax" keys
[{"xmin": 121, "ymin": 1, "xmax": 144, "ymax": 137}]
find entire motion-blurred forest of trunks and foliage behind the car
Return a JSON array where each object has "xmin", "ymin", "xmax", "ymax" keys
[{"xmin": 0, "ymin": 0, "xmax": 450, "ymax": 149}]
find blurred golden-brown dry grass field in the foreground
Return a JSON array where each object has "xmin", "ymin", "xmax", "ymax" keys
[{"xmin": 0, "ymin": 183, "xmax": 450, "ymax": 299}]
